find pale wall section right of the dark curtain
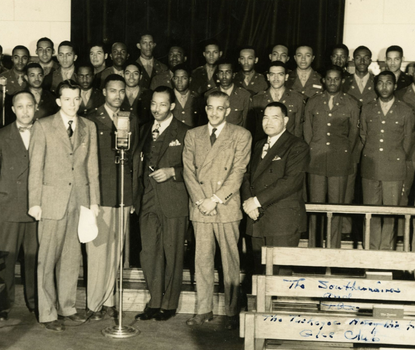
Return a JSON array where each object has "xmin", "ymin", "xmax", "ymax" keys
[{"xmin": 343, "ymin": 0, "xmax": 415, "ymax": 62}]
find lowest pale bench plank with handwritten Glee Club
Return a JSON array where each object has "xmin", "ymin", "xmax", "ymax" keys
[{"xmin": 252, "ymin": 312, "xmax": 415, "ymax": 346}]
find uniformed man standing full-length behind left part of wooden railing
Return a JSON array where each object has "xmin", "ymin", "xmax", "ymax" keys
[{"xmin": 304, "ymin": 66, "xmax": 359, "ymax": 248}]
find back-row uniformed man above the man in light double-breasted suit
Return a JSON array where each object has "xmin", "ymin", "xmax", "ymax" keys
[{"xmin": 190, "ymin": 39, "xmax": 222, "ymax": 95}]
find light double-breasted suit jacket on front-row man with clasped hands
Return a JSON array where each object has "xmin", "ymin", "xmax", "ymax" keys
[{"xmin": 183, "ymin": 123, "xmax": 252, "ymax": 223}]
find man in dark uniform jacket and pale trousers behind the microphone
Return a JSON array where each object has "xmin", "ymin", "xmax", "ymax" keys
[{"xmin": 86, "ymin": 74, "xmax": 137, "ymax": 320}]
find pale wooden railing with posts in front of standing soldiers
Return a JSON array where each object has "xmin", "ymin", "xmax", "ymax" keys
[{"xmin": 306, "ymin": 203, "xmax": 415, "ymax": 252}]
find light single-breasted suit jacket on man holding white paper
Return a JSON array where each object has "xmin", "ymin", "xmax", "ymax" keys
[{"xmin": 29, "ymin": 112, "xmax": 100, "ymax": 220}]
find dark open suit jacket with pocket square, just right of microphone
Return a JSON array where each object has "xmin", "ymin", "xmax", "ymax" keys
[{"xmin": 133, "ymin": 117, "xmax": 189, "ymax": 218}]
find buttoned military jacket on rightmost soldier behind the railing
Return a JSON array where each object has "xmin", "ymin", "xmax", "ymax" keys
[{"xmin": 360, "ymin": 98, "xmax": 415, "ymax": 181}]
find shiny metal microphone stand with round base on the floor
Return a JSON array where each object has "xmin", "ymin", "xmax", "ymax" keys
[{"xmin": 102, "ymin": 132, "xmax": 140, "ymax": 338}]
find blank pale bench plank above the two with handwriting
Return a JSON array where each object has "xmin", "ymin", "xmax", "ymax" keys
[{"xmin": 261, "ymin": 247, "xmax": 415, "ymax": 270}]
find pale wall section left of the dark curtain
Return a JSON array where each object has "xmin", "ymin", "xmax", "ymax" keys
[{"xmin": 0, "ymin": 0, "xmax": 71, "ymax": 56}]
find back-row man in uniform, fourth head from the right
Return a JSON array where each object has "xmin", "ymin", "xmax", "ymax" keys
[{"xmin": 286, "ymin": 46, "xmax": 323, "ymax": 99}]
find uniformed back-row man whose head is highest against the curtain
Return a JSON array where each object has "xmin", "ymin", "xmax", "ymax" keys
[{"xmin": 136, "ymin": 33, "xmax": 167, "ymax": 89}]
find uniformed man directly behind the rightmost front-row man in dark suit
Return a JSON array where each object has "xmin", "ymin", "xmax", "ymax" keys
[{"xmin": 248, "ymin": 61, "xmax": 304, "ymax": 143}]
